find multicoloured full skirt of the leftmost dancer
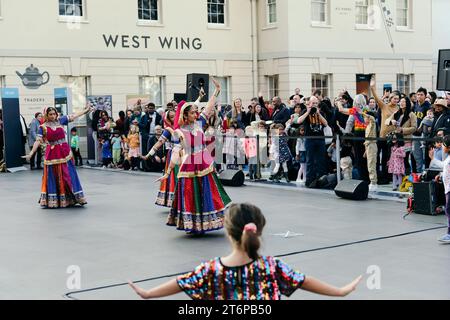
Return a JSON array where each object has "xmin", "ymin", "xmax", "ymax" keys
[{"xmin": 39, "ymin": 160, "xmax": 87, "ymax": 208}]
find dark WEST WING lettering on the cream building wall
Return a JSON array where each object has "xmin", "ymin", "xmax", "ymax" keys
[{"xmin": 103, "ymin": 34, "xmax": 202, "ymax": 50}]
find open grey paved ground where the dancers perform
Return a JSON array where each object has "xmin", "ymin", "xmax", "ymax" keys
[{"xmin": 0, "ymin": 169, "xmax": 450, "ymax": 299}]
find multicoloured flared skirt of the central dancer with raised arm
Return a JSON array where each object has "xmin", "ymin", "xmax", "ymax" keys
[{"xmin": 167, "ymin": 172, "xmax": 231, "ymax": 234}]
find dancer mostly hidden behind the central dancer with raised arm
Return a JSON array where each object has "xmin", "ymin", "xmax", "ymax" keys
[{"xmin": 142, "ymin": 110, "xmax": 178, "ymax": 208}]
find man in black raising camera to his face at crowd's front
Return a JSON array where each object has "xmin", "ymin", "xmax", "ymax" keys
[{"xmin": 298, "ymin": 96, "xmax": 328, "ymax": 188}]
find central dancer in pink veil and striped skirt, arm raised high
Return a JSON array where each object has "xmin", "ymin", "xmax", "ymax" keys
[{"xmin": 157, "ymin": 79, "xmax": 231, "ymax": 234}]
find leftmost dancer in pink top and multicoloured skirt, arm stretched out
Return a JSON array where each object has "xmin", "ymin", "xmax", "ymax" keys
[{"xmin": 23, "ymin": 106, "xmax": 93, "ymax": 208}]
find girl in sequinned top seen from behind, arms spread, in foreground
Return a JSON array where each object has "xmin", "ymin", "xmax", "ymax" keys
[{"xmin": 129, "ymin": 204, "xmax": 362, "ymax": 300}]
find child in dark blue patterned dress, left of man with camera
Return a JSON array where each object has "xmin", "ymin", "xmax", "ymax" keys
[{"xmin": 270, "ymin": 123, "xmax": 292, "ymax": 183}]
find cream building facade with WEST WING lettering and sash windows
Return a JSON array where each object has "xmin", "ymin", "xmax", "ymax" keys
[{"xmin": 0, "ymin": 0, "xmax": 433, "ymax": 120}]
